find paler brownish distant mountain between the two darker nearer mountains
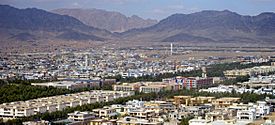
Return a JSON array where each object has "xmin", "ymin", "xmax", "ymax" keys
[{"xmin": 51, "ymin": 9, "xmax": 157, "ymax": 32}]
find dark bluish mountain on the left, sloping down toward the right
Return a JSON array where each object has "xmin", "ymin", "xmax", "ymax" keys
[{"xmin": 0, "ymin": 5, "xmax": 114, "ymax": 41}]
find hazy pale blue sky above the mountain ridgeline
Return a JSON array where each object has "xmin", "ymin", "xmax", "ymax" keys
[{"xmin": 0, "ymin": 0, "xmax": 275, "ymax": 20}]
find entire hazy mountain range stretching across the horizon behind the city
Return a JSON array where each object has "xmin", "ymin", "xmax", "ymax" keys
[{"xmin": 0, "ymin": 5, "xmax": 275, "ymax": 43}]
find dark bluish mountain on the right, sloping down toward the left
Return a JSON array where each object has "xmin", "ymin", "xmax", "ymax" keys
[{"xmin": 122, "ymin": 10, "xmax": 275, "ymax": 43}]
